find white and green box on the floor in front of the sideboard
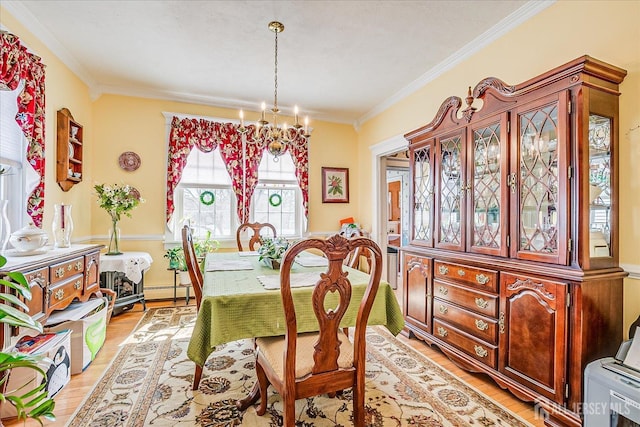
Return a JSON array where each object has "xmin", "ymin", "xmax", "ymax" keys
[{"xmin": 45, "ymin": 297, "xmax": 109, "ymax": 375}]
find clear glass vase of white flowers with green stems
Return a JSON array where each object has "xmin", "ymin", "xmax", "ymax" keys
[{"xmin": 93, "ymin": 184, "xmax": 144, "ymax": 255}]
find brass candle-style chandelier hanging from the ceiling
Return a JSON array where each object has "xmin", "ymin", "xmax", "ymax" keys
[{"xmin": 240, "ymin": 21, "xmax": 311, "ymax": 161}]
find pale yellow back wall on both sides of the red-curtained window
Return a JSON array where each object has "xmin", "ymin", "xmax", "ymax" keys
[{"xmin": 89, "ymin": 95, "xmax": 358, "ymax": 298}]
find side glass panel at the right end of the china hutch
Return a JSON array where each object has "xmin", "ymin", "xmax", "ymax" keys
[{"xmin": 589, "ymin": 114, "xmax": 611, "ymax": 257}]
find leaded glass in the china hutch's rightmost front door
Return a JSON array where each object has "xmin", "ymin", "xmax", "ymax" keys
[{"xmin": 519, "ymin": 104, "xmax": 558, "ymax": 254}]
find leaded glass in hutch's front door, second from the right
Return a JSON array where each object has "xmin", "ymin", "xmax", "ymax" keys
[{"xmin": 472, "ymin": 123, "xmax": 501, "ymax": 248}]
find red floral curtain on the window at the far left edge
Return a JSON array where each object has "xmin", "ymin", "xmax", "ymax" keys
[{"xmin": 0, "ymin": 31, "xmax": 45, "ymax": 227}]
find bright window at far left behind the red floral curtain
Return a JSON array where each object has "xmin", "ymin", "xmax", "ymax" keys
[{"xmin": 0, "ymin": 83, "xmax": 39, "ymax": 236}]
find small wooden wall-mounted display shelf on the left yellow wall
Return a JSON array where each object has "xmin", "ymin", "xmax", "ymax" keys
[{"xmin": 56, "ymin": 108, "xmax": 84, "ymax": 191}]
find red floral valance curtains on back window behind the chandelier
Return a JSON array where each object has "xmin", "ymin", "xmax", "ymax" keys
[{"xmin": 167, "ymin": 113, "xmax": 309, "ymax": 227}]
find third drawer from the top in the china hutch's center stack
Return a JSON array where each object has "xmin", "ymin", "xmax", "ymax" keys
[{"xmin": 433, "ymin": 298, "xmax": 498, "ymax": 344}]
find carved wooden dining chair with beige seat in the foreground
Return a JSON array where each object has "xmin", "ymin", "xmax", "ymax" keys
[{"xmin": 256, "ymin": 235, "xmax": 382, "ymax": 427}]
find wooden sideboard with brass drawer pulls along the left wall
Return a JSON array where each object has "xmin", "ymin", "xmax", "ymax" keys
[{"xmin": 0, "ymin": 245, "xmax": 103, "ymax": 348}]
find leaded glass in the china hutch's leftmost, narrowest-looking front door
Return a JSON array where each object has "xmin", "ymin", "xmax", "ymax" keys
[{"xmin": 413, "ymin": 144, "xmax": 433, "ymax": 246}]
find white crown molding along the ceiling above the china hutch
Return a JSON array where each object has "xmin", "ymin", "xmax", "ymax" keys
[{"xmin": 353, "ymin": 0, "xmax": 557, "ymax": 129}]
